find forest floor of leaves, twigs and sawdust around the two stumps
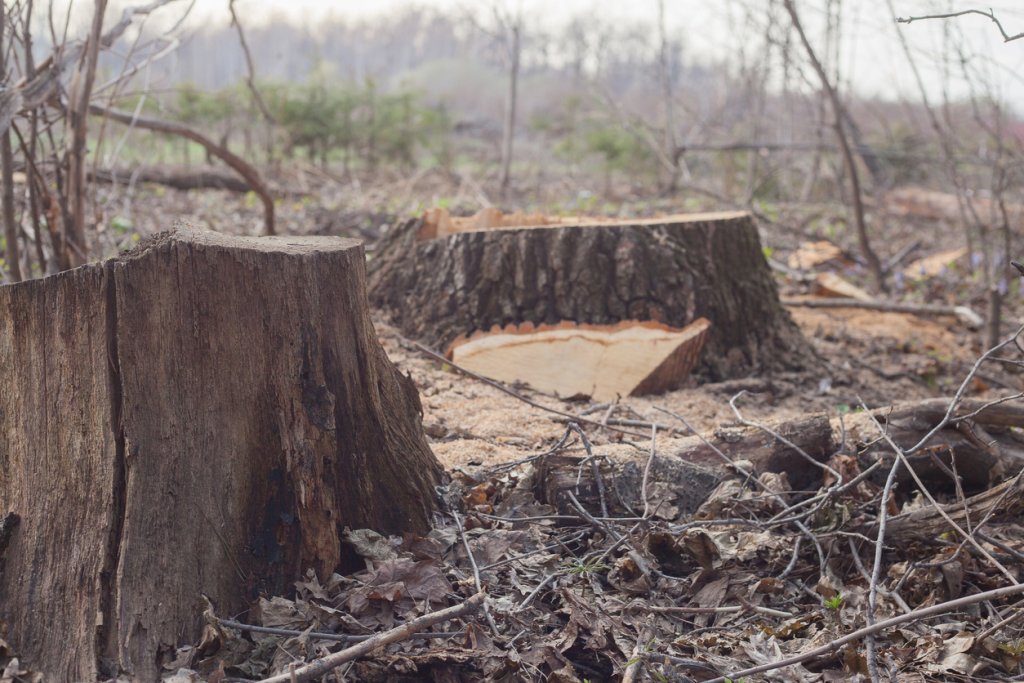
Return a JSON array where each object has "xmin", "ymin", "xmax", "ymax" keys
[{"xmin": 83, "ymin": 169, "xmax": 1024, "ymax": 682}]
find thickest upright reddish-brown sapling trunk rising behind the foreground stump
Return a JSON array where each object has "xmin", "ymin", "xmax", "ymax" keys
[{"xmin": 68, "ymin": 0, "xmax": 106, "ymax": 265}]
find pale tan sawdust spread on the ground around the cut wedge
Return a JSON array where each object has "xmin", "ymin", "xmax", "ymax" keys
[{"xmin": 377, "ymin": 308, "xmax": 984, "ymax": 473}]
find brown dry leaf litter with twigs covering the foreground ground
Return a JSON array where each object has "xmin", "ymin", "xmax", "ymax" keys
[{"xmin": 155, "ymin": 403, "xmax": 1024, "ymax": 682}]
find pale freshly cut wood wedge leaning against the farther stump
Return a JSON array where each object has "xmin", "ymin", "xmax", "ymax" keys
[{"xmin": 447, "ymin": 317, "xmax": 711, "ymax": 400}]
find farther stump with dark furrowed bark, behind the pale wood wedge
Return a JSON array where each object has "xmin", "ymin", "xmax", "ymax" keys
[{"xmin": 370, "ymin": 213, "xmax": 813, "ymax": 380}]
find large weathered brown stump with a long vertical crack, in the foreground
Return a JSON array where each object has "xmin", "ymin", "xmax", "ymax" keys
[{"xmin": 0, "ymin": 230, "xmax": 443, "ymax": 681}]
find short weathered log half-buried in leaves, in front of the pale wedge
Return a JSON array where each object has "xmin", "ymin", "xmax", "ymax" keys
[{"xmin": 535, "ymin": 415, "xmax": 835, "ymax": 519}]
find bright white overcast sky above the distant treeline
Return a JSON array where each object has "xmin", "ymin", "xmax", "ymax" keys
[{"xmin": 74, "ymin": 0, "xmax": 1024, "ymax": 116}]
